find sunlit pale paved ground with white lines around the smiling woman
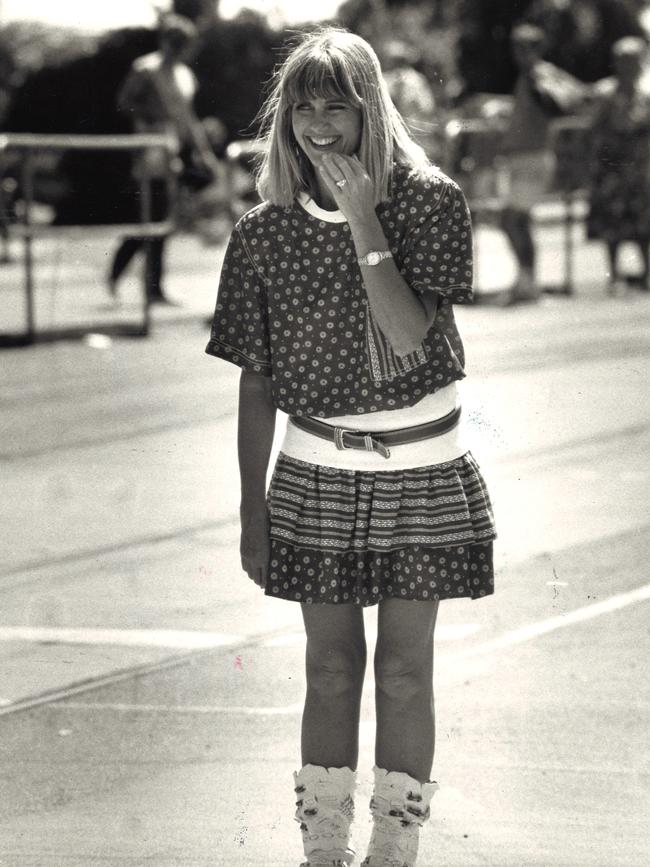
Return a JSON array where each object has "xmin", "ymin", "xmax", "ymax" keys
[{"xmin": 0, "ymin": 220, "xmax": 650, "ymax": 867}]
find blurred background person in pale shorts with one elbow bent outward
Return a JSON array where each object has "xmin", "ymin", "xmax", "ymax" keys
[{"xmin": 501, "ymin": 24, "xmax": 587, "ymax": 302}]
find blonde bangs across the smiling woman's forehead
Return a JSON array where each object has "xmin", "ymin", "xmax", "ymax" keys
[{"xmin": 283, "ymin": 50, "xmax": 361, "ymax": 106}]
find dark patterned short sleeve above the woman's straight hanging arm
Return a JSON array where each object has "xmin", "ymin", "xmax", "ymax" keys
[{"xmin": 205, "ymin": 227, "xmax": 271, "ymax": 376}]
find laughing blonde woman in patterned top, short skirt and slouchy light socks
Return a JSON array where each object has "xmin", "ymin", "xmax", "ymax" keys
[{"xmin": 207, "ymin": 28, "xmax": 494, "ymax": 867}]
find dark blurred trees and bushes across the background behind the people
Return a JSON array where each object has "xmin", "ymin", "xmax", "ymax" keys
[{"xmin": 3, "ymin": 0, "xmax": 642, "ymax": 222}]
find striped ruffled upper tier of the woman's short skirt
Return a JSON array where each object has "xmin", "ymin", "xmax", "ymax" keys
[{"xmin": 269, "ymin": 452, "xmax": 496, "ymax": 552}]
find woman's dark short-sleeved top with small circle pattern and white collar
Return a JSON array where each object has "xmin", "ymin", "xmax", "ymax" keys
[{"xmin": 206, "ymin": 167, "xmax": 472, "ymax": 418}]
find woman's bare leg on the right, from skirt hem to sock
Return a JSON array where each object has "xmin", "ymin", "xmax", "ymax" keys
[{"xmin": 375, "ymin": 599, "xmax": 438, "ymax": 782}]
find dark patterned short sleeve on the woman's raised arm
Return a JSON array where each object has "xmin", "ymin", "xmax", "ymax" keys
[{"xmin": 400, "ymin": 180, "xmax": 473, "ymax": 304}]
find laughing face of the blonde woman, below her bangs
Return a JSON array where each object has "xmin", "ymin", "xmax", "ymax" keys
[{"xmin": 291, "ymin": 96, "xmax": 363, "ymax": 166}]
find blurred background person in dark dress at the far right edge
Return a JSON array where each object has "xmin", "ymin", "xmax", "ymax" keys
[{"xmin": 587, "ymin": 36, "xmax": 650, "ymax": 295}]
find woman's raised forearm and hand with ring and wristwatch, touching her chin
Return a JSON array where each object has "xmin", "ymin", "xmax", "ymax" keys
[{"xmin": 321, "ymin": 154, "xmax": 438, "ymax": 355}]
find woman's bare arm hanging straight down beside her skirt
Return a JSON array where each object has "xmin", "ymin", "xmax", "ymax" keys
[{"xmin": 237, "ymin": 370, "xmax": 276, "ymax": 587}]
